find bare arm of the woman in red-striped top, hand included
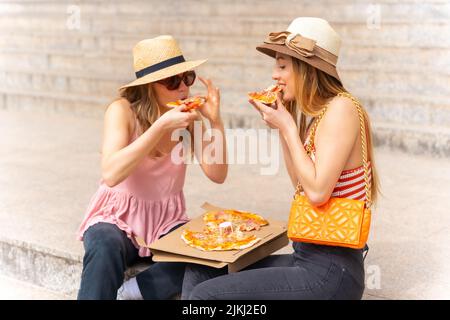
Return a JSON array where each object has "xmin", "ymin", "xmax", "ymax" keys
[{"xmin": 250, "ymin": 98, "xmax": 359, "ymax": 206}]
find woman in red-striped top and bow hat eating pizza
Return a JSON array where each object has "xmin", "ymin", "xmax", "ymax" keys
[{"xmin": 182, "ymin": 18, "xmax": 377, "ymax": 300}]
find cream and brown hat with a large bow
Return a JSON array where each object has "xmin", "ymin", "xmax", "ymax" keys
[{"xmin": 256, "ymin": 17, "xmax": 341, "ymax": 81}]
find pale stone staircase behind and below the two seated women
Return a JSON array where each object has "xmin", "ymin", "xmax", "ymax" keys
[{"xmin": 0, "ymin": 0, "xmax": 450, "ymax": 297}]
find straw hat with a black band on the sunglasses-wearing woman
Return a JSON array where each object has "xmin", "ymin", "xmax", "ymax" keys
[{"xmin": 120, "ymin": 35, "xmax": 206, "ymax": 89}]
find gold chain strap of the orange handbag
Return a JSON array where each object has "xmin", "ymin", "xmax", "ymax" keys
[{"xmin": 294, "ymin": 92, "xmax": 372, "ymax": 208}]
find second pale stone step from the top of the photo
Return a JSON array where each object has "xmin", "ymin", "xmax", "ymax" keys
[{"xmin": 0, "ymin": 11, "xmax": 450, "ymax": 48}]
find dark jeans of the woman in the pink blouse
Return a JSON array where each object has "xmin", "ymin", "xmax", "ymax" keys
[{"xmin": 78, "ymin": 222, "xmax": 186, "ymax": 300}]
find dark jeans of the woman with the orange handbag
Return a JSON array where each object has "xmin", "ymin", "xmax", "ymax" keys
[{"xmin": 181, "ymin": 242, "xmax": 364, "ymax": 300}]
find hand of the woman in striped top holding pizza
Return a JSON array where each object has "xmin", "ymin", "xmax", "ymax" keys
[{"xmin": 249, "ymin": 94, "xmax": 297, "ymax": 132}]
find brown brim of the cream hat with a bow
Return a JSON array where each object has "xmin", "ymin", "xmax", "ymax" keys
[{"xmin": 256, "ymin": 43, "xmax": 341, "ymax": 82}]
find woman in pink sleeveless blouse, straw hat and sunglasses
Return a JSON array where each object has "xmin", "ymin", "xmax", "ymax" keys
[{"xmin": 78, "ymin": 36, "xmax": 228, "ymax": 299}]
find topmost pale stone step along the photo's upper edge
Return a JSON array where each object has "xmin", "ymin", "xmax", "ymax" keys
[{"xmin": 0, "ymin": 0, "xmax": 450, "ymax": 24}]
